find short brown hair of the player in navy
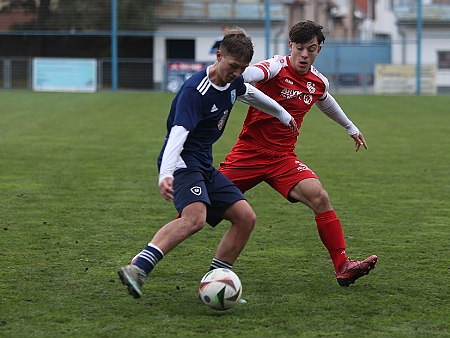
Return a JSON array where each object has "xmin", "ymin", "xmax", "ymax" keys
[{"xmin": 219, "ymin": 27, "xmax": 254, "ymax": 63}]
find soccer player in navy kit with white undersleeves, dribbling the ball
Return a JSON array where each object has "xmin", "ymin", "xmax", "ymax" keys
[{"xmin": 118, "ymin": 29, "xmax": 297, "ymax": 298}]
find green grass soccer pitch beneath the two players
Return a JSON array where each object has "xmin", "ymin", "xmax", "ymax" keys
[{"xmin": 0, "ymin": 91, "xmax": 450, "ymax": 338}]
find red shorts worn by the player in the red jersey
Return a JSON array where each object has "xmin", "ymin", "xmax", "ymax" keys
[{"xmin": 219, "ymin": 140, "xmax": 318, "ymax": 202}]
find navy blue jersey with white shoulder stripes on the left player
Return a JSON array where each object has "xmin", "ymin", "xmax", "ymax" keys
[{"xmin": 158, "ymin": 69, "xmax": 246, "ymax": 169}]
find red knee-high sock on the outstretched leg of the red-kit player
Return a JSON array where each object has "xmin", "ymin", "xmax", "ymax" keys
[{"xmin": 316, "ymin": 210, "xmax": 347, "ymax": 272}]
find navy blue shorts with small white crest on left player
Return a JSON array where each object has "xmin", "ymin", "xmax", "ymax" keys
[{"xmin": 173, "ymin": 167, "xmax": 245, "ymax": 227}]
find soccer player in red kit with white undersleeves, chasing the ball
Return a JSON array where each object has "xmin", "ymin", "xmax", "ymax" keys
[{"xmin": 219, "ymin": 20, "xmax": 378, "ymax": 287}]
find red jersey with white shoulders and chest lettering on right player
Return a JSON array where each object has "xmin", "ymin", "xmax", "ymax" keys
[{"xmin": 239, "ymin": 56, "xmax": 329, "ymax": 152}]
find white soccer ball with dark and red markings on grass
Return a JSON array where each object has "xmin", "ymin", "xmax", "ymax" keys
[{"xmin": 198, "ymin": 269, "xmax": 242, "ymax": 311}]
